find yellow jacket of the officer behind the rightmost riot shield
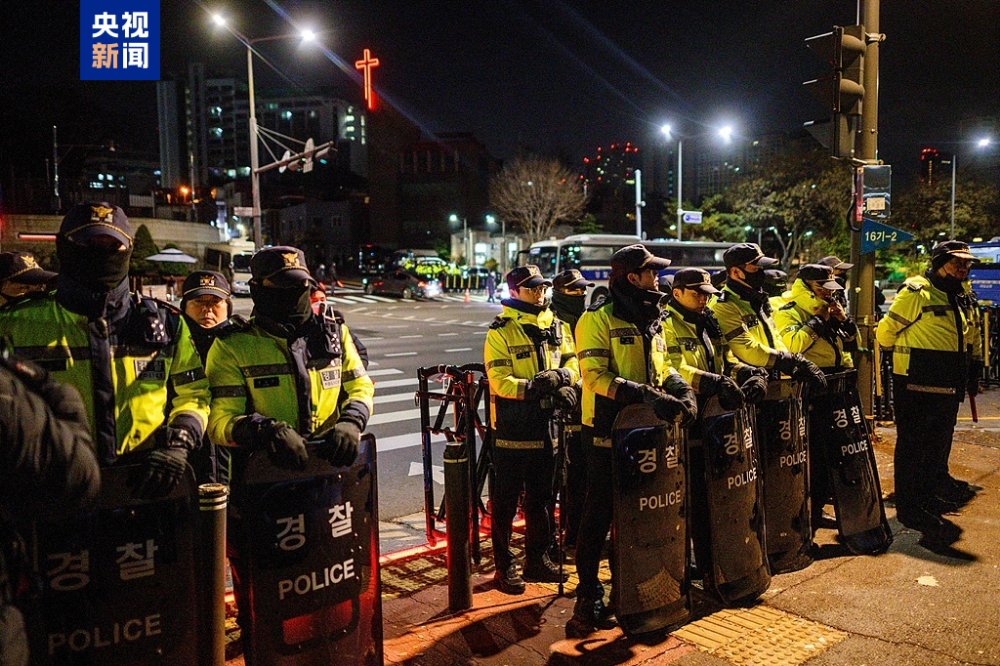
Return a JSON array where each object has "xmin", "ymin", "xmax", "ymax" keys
[{"xmin": 774, "ymin": 280, "xmax": 854, "ymax": 370}]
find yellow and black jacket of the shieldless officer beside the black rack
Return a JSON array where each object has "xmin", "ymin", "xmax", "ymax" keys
[{"xmin": 483, "ymin": 305, "xmax": 580, "ymax": 449}]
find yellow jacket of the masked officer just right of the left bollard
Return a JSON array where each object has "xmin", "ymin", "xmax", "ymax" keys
[{"xmin": 207, "ymin": 319, "xmax": 375, "ymax": 446}]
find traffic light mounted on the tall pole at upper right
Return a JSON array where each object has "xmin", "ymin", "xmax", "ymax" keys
[{"xmin": 805, "ymin": 25, "xmax": 866, "ymax": 158}]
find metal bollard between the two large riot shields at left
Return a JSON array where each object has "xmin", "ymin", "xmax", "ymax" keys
[{"xmin": 198, "ymin": 483, "xmax": 229, "ymax": 666}]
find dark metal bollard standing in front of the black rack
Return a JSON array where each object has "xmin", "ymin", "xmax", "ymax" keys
[{"xmin": 444, "ymin": 442, "xmax": 472, "ymax": 611}]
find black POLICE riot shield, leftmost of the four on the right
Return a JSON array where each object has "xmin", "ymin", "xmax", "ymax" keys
[{"xmin": 612, "ymin": 405, "xmax": 691, "ymax": 636}]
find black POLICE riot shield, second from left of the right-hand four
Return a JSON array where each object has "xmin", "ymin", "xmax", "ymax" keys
[{"xmin": 691, "ymin": 398, "xmax": 771, "ymax": 603}]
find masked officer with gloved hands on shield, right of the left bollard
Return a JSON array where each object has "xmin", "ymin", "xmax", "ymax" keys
[{"xmin": 207, "ymin": 246, "xmax": 375, "ymax": 652}]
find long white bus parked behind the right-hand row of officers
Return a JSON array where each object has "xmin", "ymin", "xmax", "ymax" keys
[{"xmin": 527, "ymin": 234, "xmax": 732, "ymax": 303}]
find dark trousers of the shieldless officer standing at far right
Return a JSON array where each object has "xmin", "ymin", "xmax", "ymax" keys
[{"xmin": 893, "ymin": 376, "xmax": 959, "ymax": 511}]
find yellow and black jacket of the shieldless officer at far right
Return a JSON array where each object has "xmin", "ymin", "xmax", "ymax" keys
[{"xmin": 876, "ymin": 276, "xmax": 969, "ymax": 396}]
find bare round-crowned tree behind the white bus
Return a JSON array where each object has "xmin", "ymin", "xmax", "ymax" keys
[{"xmin": 490, "ymin": 155, "xmax": 587, "ymax": 243}]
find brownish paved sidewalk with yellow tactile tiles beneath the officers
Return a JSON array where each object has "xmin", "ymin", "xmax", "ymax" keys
[{"xmin": 229, "ymin": 390, "xmax": 1000, "ymax": 666}]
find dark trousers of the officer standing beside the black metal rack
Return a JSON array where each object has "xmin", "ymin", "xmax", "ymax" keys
[{"xmin": 490, "ymin": 446, "xmax": 555, "ymax": 571}]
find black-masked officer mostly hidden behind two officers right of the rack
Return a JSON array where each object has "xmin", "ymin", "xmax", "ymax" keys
[{"xmin": 552, "ymin": 269, "xmax": 594, "ymax": 552}]
